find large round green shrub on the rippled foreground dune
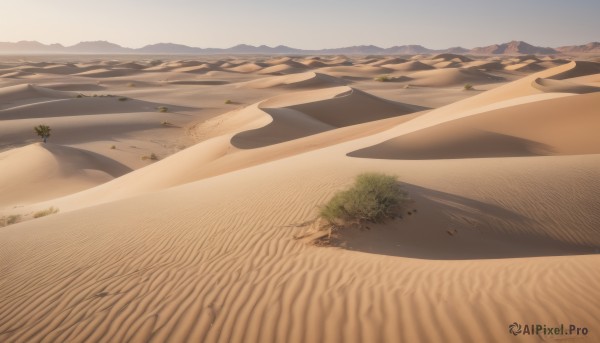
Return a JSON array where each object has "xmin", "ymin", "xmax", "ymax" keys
[{"xmin": 320, "ymin": 173, "xmax": 409, "ymax": 226}]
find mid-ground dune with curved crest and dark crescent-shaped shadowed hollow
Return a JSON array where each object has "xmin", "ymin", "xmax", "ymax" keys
[{"xmin": 2, "ymin": 87, "xmax": 419, "ymax": 211}]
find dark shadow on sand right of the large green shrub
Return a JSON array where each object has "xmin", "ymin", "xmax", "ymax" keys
[{"xmin": 334, "ymin": 184, "xmax": 594, "ymax": 260}]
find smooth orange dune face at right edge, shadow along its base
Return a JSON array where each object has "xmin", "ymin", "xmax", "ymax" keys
[{"xmin": 350, "ymin": 93, "xmax": 600, "ymax": 159}]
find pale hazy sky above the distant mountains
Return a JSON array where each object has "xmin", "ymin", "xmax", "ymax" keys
[{"xmin": 0, "ymin": 0, "xmax": 600, "ymax": 49}]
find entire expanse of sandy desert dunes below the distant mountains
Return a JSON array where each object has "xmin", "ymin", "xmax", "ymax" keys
[{"xmin": 0, "ymin": 54, "xmax": 600, "ymax": 342}]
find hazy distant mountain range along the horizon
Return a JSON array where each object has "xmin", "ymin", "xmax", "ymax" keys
[{"xmin": 0, "ymin": 41, "xmax": 600, "ymax": 55}]
